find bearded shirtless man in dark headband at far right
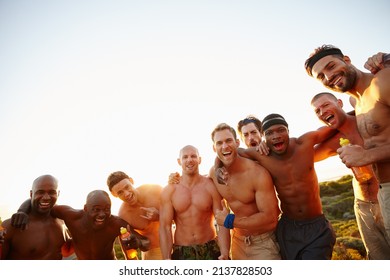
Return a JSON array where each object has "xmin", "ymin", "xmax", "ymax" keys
[{"xmin": 305, "ymin": 45, "xmax": 390, "ymax": 237}]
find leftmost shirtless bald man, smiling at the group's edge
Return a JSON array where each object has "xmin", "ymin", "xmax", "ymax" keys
[{"xmin": 1, "ymin": 175, "xmax": 71, "ymax": 260}]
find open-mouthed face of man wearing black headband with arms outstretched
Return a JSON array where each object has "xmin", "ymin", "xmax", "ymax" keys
[{"xmin": 264, "ymin": 124, "xmax": 290, "ymax": 155}]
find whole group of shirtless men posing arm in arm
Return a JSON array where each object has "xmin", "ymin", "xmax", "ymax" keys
[{"xmin": 0, "ymin": 45, "xmax": 390, "ymax": 260}]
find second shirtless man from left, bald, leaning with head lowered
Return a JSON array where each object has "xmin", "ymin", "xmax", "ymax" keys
[{"xmin": 12, "ymin": 190, "xmax": 149, "ymax": 260}]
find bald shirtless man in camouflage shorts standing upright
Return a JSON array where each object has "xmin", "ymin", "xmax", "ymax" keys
[{"xmin": 160, "ymin": 145, "xmax": 230, "ymax": 260}]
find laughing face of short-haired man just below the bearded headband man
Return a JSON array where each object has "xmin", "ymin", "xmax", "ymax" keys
[{"xmin": 312, "ymin": 94, "xmax": 346, "ymax": 129}]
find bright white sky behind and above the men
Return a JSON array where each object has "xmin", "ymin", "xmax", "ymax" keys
[{"xmin": 0, "ymin": 0, "xmax": 390, "ymax": 219}]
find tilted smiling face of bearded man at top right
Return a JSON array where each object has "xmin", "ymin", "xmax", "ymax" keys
[{"xmin": 312, "ymin": 55, "xmax": 357, "ymax": 92}]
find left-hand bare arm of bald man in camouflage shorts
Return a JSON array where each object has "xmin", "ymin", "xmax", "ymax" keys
[{"xmin": 159, "ymin": 185, "xmax": 174, "ymax": 260}]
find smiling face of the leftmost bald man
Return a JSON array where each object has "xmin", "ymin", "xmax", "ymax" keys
[{"xmin": 30, "ymin": 175, "xmax": 59, "ymax": 217}]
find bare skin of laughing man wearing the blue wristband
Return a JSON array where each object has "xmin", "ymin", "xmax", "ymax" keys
[{"xmin": 210, "ymin": 129, "xmax": 280, "ymax": 236}]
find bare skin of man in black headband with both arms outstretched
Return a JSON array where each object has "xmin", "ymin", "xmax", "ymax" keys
[{"xmin": 240, "ymin": 124, "xmax": 334, "ymax": 220}]
